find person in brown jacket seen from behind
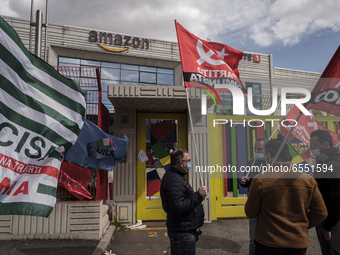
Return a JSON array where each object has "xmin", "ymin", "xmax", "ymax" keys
[{"xmin": 245, "ymin": 139, "xmax": 327, "ymax": 255}]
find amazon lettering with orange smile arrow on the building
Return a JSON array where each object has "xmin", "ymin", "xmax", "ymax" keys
[{"xmin": 89, "ymin": 30, "xmax": 150, "ymax": 52}]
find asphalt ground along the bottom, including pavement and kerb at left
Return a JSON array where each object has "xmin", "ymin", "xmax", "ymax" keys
[{"xmin": 0, "ymin": 219, "xmax": 321, "ymax": 255}]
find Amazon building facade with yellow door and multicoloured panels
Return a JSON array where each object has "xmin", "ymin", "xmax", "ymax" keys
[{"xmin": 4, "ymin": 17, "xmax": 339, "ymax": 229}]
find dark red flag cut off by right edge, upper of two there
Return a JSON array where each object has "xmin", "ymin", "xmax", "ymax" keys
[{"xmin": 305, "ymin": 46, "xmax": 340, "ymax": 116}]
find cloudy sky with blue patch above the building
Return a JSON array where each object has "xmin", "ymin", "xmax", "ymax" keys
[{"xmin": 0, "ymin": 0, "xmax": 340, "ymax": 73}]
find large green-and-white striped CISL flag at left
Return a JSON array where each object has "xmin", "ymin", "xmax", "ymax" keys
[{"xmin": 0, "ymin": 17, "xmax": 86, "ymax": 217}]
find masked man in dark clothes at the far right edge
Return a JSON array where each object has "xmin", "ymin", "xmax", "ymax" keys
[{"xmin": 310, "ymin": 130, "xmax": 340, "ymax": 255}]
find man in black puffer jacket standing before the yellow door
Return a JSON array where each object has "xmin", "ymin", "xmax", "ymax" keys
[{"xmin": 160, "ymin": 150, "xmax": 207, "ymax": 255}]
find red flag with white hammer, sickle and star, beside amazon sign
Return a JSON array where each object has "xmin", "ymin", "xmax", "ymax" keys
[{"xmin": 175, "ymin": 21, "xmax": 246, "ymax": 99}]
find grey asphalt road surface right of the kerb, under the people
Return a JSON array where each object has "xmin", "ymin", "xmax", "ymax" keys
[{"xmin": 107, "ymin": 219, "xmax": 321, "ymax": 255}]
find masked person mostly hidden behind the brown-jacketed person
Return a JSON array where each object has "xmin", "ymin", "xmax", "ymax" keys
[{"xmin": 240, "ymin": 137, "xmax": 268, "ymax": 255}]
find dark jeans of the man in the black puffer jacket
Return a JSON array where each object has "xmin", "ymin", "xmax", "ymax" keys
[{"xmin": 168, "ymin": 230, "xmax": 196, "ymax": 255}]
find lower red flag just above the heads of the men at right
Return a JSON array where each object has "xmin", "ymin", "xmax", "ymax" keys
[{"xmin": 281, "ymin": 105, "xmax": 340, "ymax": 149}]
